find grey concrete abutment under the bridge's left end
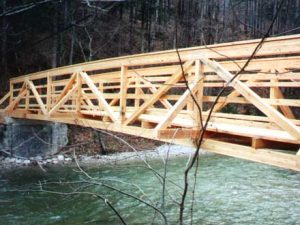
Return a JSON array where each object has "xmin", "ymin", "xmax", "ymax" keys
[{"xmin": 0, "ymin": 118, "xmax": 68, "ymax": 158}]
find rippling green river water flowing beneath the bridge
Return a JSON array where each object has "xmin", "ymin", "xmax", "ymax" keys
[{"xmin": 0, "ymin": 155, "xmax": 300, "ymax": 225}]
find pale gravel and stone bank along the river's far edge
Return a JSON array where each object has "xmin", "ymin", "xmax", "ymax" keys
[{"xmin": 0, "ymin": 144, "xmax": 207, "ymax": 170}]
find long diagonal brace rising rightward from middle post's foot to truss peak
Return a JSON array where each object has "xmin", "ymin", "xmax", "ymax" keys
[{"xmin": 124, "ymin": 61, "xmax": 194, "ymax": 125}]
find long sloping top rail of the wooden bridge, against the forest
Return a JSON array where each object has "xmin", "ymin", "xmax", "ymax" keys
[{"xmin": 11, "ymin": 35, "xmax": 300, "ymax": 82}]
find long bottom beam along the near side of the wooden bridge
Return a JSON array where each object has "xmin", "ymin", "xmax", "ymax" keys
[{"xmin": 7, "ymin": 112, "xmax": 300, "ymax": 171}]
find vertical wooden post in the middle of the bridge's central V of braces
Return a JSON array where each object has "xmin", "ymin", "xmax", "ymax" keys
[{"xmin": 120, "ymin": 65, "xmax": 128, "ymax": 123}]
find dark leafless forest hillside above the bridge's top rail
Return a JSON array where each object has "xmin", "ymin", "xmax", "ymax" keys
[{"xmin": 0, "ymin": 0, "xmax": 300, "ymax": 91}]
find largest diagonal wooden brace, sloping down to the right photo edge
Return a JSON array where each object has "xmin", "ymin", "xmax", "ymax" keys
[{"xmin": 201, "ymin": 58, "xmax": 300, "ymax": 140}]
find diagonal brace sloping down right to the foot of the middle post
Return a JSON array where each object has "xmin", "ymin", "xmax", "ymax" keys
[{"xmin": 80, "ymin": 72, "xmax": 118, "ymax": 122}]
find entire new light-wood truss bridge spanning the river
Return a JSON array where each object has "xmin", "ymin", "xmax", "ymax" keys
[{"xmin": 0, "ymin": 35, "xmax": 300, "ymax": 170}]
